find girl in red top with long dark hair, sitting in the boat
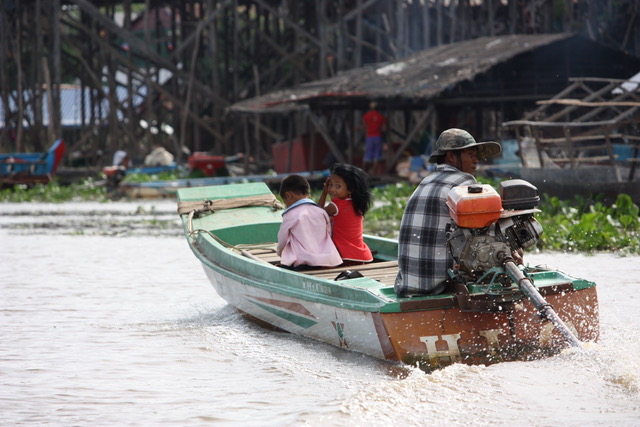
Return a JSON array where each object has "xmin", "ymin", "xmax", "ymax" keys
[{"xmin": 318, "ymin": 163, "xmax": 373, "ymax": 265}]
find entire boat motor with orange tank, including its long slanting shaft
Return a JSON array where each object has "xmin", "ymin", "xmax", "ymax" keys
[{"xmin": 447, "ymin": 179, "xmax": 582, "ymax": 348}]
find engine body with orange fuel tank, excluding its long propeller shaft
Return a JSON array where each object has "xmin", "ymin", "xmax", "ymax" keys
[{"xmin": 447, "ymin": 179, "xmax": 542, "ymax": 282}]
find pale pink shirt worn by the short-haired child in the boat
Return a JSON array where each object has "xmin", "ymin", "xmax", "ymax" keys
[{"xmin": 277, "ymin": 199, "xmax": 342, "ymax": 267}]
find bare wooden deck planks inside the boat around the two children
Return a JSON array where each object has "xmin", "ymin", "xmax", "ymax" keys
[{"xmin": 243, "ymin": 249, "xmax": 398, "ymax": 286}]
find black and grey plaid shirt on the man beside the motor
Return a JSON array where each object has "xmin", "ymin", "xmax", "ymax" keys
[{"xmin": 395, "ymin": 164, "xmax": 477, "ymax": 296}]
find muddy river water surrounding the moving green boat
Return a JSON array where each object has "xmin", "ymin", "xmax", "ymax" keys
[{"xmin": 0, "ymin": 200, "xmax": 640, "ymax": 427}]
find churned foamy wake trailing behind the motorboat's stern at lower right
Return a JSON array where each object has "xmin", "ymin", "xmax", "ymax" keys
[{"xmin": 332, "ymin": 330, "xmax": 640, "ymax": 426}]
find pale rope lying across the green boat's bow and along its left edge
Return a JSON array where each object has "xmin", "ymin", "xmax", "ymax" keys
[{"xmin": 178, "ymin": 194, "xmax": 284, "ymax": 253}]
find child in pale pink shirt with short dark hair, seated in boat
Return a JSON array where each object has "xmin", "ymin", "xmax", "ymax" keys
[{"xmin": 277, "ymin": 175, "xmax": 342, "ymax": 270}]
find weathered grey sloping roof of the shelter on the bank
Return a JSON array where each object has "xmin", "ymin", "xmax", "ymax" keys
[{"xmin": 229, "ymin": 34, "xmax": 571, "ymax": 113}]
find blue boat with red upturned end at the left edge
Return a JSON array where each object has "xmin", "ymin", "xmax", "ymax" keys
[{"xmin": 0, "ymin": 139, "xmax": 66, "ymax": 185}]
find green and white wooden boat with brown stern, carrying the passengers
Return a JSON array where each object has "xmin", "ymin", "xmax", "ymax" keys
[{"xmin": 178, "ymin": 183, "xmax": 599, "ymax": 371}]
